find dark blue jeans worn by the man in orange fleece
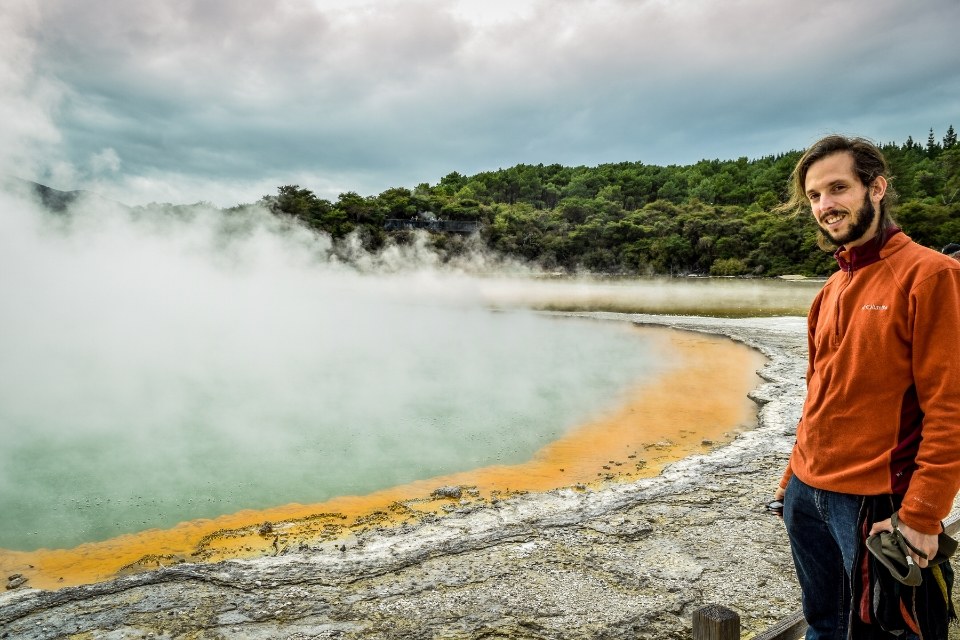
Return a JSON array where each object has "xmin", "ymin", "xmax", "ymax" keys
[{"xmin": 783, "ymin": 477, "xmax": 863, "ymax": 640}]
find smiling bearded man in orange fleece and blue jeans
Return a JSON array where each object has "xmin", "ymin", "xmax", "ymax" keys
[{"xmin": 776, "ymin": 136, "xmax": 960, "ymax": 640}]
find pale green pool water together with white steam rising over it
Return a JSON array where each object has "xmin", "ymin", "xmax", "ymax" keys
[{"xmin": 0, "ymin": 188, "xmax": 824, "ymax": 550}]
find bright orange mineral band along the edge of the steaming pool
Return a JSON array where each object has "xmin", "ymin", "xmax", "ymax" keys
[{"xmin": 0, "ymin": 328, "xmax": 763, "ymax": 589}]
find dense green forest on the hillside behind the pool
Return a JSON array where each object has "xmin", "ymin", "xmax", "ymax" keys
[{"xmin": 240, "ymin": 130, "xmax": 960, "ymax": 277}]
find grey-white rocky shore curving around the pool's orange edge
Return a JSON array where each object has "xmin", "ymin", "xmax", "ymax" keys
[{"xmin": 0, "ymin": 313, "xmax": 820, "ymax": 639}]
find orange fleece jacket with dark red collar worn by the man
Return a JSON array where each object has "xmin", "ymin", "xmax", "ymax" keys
[{"xmin": 780, "ymin": 232, "xmax": 960, "ymax": 534}]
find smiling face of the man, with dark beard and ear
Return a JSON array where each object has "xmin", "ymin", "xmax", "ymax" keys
[{"xmin": 804, "ymin": 152, "xmax": 886, "ymax": 249}]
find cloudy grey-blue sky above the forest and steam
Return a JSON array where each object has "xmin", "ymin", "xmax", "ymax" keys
[{"xmin": 0, "ymin": 0, "xmax": 960, "ymax": 205}]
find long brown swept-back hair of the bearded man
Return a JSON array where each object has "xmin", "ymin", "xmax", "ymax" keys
[{"xmin": 778, "ymin": 134, "xmax": 897, "ymax": 251}]
